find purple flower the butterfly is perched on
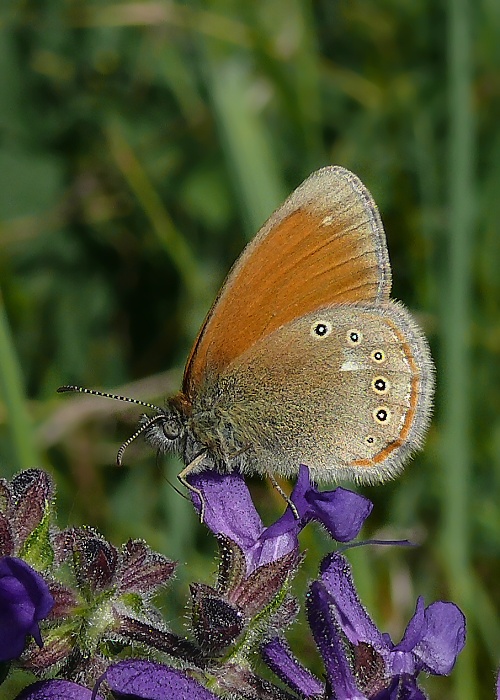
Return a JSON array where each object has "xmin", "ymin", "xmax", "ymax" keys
[{"xmin": 188, "ymin": 466, "xmax": 373, "ymax": 575}]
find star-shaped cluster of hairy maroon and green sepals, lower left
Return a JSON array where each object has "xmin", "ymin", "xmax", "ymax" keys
[{"xmin": 25, "ymin": 528, "xmax": 175, "ymax": 682}]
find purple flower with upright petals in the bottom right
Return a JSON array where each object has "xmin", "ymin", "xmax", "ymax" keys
[{"xmin": 262, "ymin": 553, "xmax": 465, "ymax": 700}]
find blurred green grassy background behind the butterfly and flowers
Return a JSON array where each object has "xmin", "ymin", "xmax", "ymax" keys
[{"xmin": 0, "ymin": 0, "xmax": 500, "ymax": 700}]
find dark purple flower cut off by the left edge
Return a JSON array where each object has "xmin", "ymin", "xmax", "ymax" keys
[{"xmin": 0, "ymin": 557, "xmax": 54, "ymax": 661}]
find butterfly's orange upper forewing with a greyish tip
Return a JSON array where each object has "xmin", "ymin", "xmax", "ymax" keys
[{"xmin": 183, "ymin": 166, "xmax": 391, "ymax": 399}]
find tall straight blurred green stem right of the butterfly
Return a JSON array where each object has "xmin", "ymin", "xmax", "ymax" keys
[{"xmin": 441, "ymin": 0, "xmax": 478, "ymax": 700}]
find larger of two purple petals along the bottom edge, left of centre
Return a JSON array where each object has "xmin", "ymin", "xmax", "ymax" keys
[{"xmin": 104, "ymin": 660, "xmax": 218, "ymax": 700}]
